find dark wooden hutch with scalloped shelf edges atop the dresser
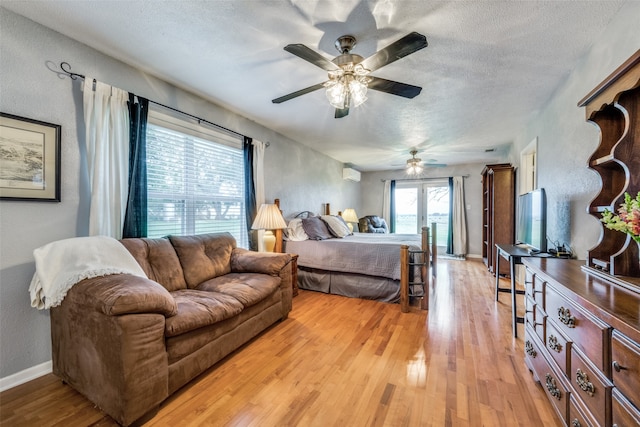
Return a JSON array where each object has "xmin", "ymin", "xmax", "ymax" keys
[{"xmin": 578, "ymin": 51, "xmax": 640, "ymax": 277}]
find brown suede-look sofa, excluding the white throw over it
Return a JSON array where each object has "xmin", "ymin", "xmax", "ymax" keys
[{"xmin": 50, "ymin": 233, "xmax": 292, "ymax": 425}]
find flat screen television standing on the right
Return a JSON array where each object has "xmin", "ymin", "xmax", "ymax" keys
[{"xmin": 516, "ymin": 188, "xmax": 547, "ymax": 253}]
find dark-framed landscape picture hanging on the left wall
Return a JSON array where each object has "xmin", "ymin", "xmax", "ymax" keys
[{"xmin": 0, "ymin": 113, "xmax": 61, "ymax": 202}]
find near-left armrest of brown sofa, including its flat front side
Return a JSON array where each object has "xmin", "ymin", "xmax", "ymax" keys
[{"xmin": 50, "ymin": 274, "xmax": 175, "ymax": 426}]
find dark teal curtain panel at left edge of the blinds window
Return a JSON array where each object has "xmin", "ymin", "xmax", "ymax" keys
[{"xmin": 122, "ymin": 93, "xmax": 149, "ymax": 237}]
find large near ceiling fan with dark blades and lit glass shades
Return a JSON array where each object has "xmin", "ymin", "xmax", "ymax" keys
[{"xmin": 271, "ymin": 32, "xmax": 427, "ymax": 119}]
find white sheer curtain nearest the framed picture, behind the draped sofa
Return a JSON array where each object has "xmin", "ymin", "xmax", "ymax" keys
[{"xmin": 83, "ymin": 77, "xmax": 129, "ymax": 239}]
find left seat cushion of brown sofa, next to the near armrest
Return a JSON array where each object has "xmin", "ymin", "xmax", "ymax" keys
[{"xmin": 165, "ymin": 289, "xmax": 243, "ymax": 337}]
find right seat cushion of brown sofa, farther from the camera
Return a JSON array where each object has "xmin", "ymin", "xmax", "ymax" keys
[{"xmin": 196, "ymin": 273, "xmax": 280, "ymax": 307}]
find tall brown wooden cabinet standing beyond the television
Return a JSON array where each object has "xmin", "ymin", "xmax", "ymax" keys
[{"xmin": 482, "ymin": 163, "xmax": 516, "ymax": 276}]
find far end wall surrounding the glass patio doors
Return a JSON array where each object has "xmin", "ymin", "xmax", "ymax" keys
[{"xmin": 356, "ymin": 164, "xmax": 484, "ymax": 256}]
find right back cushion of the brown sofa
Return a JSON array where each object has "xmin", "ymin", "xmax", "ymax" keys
[{"xmin": 169, "ymin": 233, "xmax": 236, "ymax": 289}]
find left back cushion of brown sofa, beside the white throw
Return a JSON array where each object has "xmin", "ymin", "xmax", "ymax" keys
[{"xmin": 120, "ymin": 238, "xmax": 187, "ymax": 292}]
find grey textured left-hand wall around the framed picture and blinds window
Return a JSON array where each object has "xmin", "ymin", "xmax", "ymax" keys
[{"xmin": 0, "ymin": 8, "xmax": 359, "ymax": 378}]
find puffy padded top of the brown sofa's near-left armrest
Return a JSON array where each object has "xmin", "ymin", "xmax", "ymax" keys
[{"xmin": 65, "ymin": 274, "xmax": 178, "ymax": 317}]
